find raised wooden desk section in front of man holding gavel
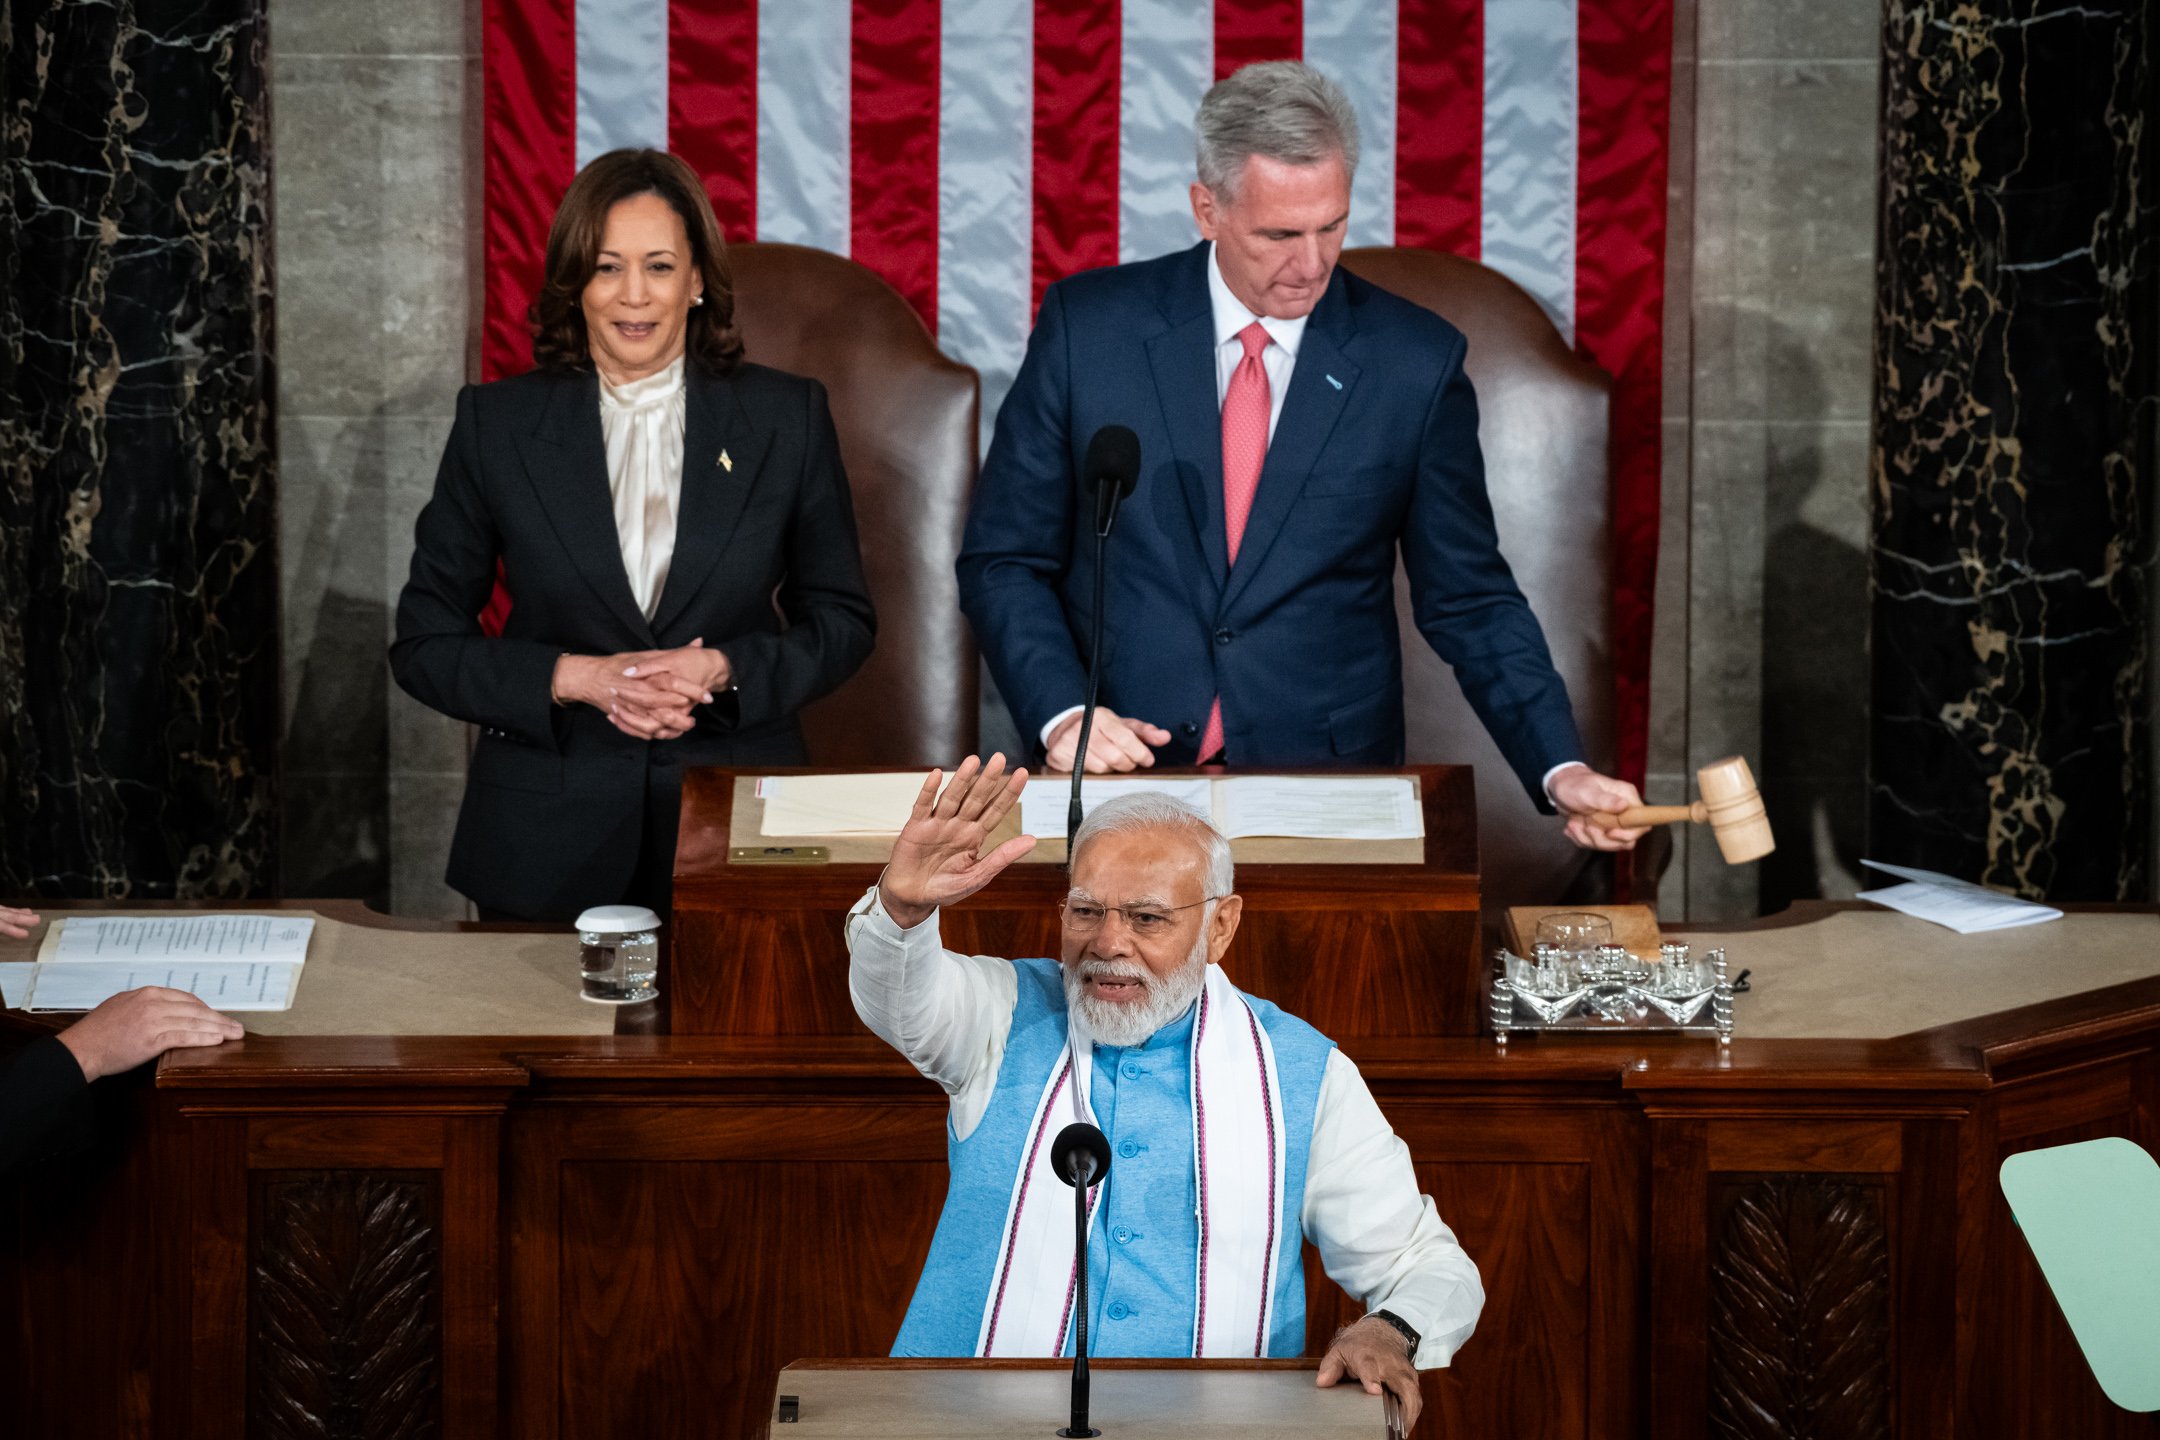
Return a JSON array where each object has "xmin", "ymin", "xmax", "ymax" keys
[{"xmin": 661, "ymin": 764, "xmax": 1484, "ymax": 1041}]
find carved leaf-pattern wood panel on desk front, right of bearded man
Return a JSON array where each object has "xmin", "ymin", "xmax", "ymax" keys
[{"xmin": 1702, "ymin": 1174, "xmax": 1892, "ymax": 1440}]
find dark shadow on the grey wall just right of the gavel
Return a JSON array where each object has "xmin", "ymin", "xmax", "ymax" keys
[{"xmin": 1758, "ymin": 317, "xmax": 1868, "ymax": 915}]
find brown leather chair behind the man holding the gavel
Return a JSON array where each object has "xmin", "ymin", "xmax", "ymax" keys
[{"xmin": 1341, "ymin": 248, "xmax": 1614, "ymax": 909}]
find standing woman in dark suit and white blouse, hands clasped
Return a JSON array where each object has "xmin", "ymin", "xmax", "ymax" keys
[{"xmin": 391, "ymin": 151, "xmax": 875, "ymax": 920}]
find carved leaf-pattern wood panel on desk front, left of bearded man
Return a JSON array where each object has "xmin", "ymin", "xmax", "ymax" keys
[{"xmin": 248, "ymin": 1170, "xmax": 443, "ymax": 1440}]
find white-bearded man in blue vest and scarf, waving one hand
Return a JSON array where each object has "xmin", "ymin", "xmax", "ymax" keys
[{"xmin": 847, "ymin": 756, "xmax": 1484, "ymax": 1421}]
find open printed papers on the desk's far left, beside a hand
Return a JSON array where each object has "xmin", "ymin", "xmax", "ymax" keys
[{"xmin": 9, "ymin": 913, "xmax": 315, "ymax": 1010}]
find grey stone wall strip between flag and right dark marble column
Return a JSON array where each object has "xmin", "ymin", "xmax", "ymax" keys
[{"xmin": 1648, "ymin": 0, "xmax": 1881, "ymax": 920}]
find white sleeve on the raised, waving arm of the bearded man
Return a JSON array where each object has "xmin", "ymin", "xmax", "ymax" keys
[{"xmin": 847, "ymin": 885, "xmax": 1019, "ymax": 1139}]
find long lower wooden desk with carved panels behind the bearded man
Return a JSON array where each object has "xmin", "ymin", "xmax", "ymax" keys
[{"xmin": 0, "ymin": 905, "xmax": 2160, "ymax": 1440}]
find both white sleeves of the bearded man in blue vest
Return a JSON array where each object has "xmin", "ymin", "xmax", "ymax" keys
[{"xmin": 847, "ymin": 885, "xmax": 1484, "ymax": 1369}]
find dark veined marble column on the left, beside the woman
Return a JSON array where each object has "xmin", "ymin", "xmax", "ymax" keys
[{"xmin": 0, "ymin": 0, "xmax": 279, "ymax": 898}]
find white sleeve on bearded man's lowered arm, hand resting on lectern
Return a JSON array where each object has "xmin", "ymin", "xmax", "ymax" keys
[{"xmin": 1305, "ymin": 1049, "xmax": 1484, "ymax": 1371}]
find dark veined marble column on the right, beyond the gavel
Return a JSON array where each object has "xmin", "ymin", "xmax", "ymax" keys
[{"xmin": 1868, "ymin": 0, "xmax": 2160, "ymax": 900}]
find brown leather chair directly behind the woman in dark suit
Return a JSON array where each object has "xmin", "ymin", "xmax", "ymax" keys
[{"xmin": 728, "ymin": 244, "xmax": 981, "ymax": 769}]
